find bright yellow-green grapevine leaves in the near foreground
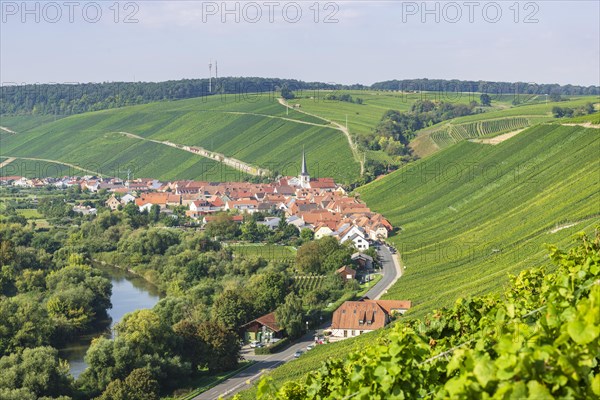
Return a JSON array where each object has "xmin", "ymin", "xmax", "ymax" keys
[{"xmin": 245, "ymin": 232, "xmax": 600, "ymax": 400}]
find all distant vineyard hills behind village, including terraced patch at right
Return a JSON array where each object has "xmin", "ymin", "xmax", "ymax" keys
[{"xmin": 0, "ymin": 90, "xmax": 594, "ymax": 183}]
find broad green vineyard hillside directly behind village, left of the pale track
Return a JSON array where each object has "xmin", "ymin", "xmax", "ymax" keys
[{"xmin": 0, "ymin": 95, "xmax": 360, "ymax": 182}]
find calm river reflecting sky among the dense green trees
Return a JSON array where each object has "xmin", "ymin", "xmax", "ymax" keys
[{"xmin": 59, "ymin": 266, "xmax": 161, "ymax": 378}]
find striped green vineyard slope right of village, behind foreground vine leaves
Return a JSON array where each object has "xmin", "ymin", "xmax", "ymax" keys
[{"xmin": 359, "ymin": 125, "xmax": 600, "ymax": 314}]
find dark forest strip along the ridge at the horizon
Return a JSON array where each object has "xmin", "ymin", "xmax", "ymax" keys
[{"xmin": 0, "ymin": 77, "xmax": 600, "ymax": 115}]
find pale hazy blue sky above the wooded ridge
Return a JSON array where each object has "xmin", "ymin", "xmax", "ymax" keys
[{"xmin": 0, "ymin": 0, "xmax": 600, "ymax": 86}]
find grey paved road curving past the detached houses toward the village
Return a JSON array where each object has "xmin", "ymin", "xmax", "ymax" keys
[{"xmin": 194, "ymin": 246, "xmax": 402, "ymax": 400}]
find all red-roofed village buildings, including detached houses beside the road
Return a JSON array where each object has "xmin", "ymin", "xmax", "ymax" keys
[{"xmin": 0, "ymin": 152, "xmax": 411, "ymax": 346}]
